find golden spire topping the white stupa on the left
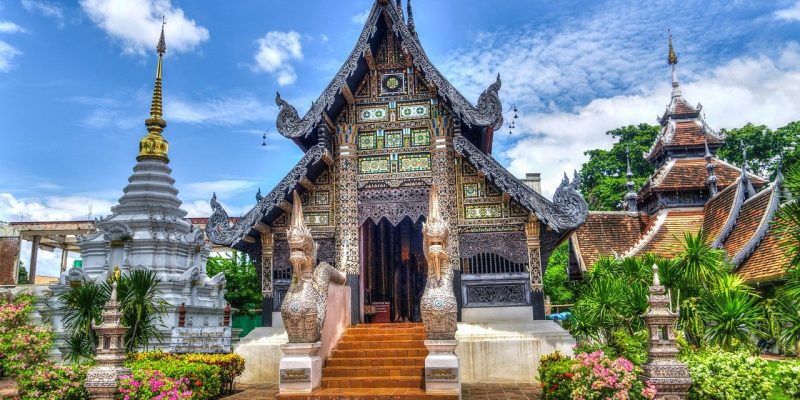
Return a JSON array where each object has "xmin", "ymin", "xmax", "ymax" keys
[{"xmin": 136, "ymin": 17, "xmax": 169, "ymax": 162}]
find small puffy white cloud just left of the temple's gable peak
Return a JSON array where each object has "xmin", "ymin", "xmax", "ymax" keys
[{"xmin": 252, "ymin": 31, "xmax": 303, "ymax": 86}]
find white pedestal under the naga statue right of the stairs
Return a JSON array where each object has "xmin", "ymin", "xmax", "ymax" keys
[{"xmin": 425, "ymin": 340, "xmax": 461, "ymax": 398}]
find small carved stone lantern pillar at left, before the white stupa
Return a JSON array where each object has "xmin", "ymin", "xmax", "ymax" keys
[{"xmin": 84, "ymin": 282, "xmax": 131, "ymax": 400}]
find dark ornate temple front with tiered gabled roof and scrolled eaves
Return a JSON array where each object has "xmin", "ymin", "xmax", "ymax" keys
[{"xmin": 206, "ymin": 0, "xmax": 587, "ymax": 326}]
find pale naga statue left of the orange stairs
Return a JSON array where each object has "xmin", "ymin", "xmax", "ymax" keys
[{"xmin": 281, "ymin": 192, "xmax": 346, "ymax": 343}]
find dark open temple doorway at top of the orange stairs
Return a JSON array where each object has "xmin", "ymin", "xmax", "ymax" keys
[{"xmin": 360, "ymin": 217, "xmax": 427, "ymax": 322}]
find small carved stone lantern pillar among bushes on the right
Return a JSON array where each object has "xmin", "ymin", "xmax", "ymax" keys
[{"xmin": 642, "ymin": 265, "xmax": 692, "ymax": 400}]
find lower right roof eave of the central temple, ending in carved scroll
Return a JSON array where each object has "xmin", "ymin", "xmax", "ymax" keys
[{"xmin": 453, "ymin": 136, "xmax": 589, "ymax": 232}]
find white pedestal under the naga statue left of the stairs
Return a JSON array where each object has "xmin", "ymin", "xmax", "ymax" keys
[{"xmin": 278, "ymin": 342, "xmax": 322, "ymax": 393}]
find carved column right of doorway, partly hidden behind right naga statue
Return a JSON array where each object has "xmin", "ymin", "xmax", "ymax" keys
[{"xmin": 431, "ymin": 134, "xmax": 463, "ymax": 321}]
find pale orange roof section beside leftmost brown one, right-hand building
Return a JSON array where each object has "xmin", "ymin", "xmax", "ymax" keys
[{"xmin": 627, "ymin": 208, "xmax": 703, "ymax": 257}]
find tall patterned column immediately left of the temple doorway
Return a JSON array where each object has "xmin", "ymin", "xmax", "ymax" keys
[{"xmin": 334, "ymin": 124, "xmax": 361, "ymax": 324}]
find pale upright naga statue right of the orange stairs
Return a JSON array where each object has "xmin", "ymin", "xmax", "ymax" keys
[{"xmin": 420, "ymin": 185, "xmax": 457, "ymax": 340}]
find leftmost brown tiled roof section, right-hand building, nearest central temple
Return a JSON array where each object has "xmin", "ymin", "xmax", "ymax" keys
[{"xmin": 570, "ymin": 211, "xmax": 649, "ymax": 269}]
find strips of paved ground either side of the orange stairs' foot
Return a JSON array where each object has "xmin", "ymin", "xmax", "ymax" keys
[{"xmin": 225, "ymin": 383, "xmax": 541, "ymax": 400}]
